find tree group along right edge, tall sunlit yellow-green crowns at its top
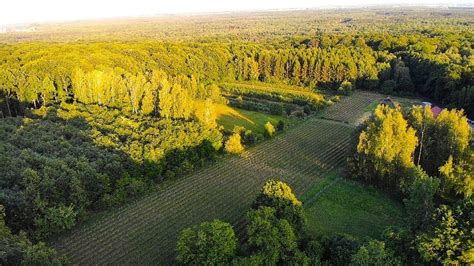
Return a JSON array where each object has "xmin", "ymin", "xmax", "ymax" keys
[{"xmin": 350, "ymin": 105, "xmax": 474, "ymax": 264}]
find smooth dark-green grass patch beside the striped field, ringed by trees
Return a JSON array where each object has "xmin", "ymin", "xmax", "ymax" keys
[{"xmin": 303, "ymin": 174, "xmax": 403, "ymax": 240}]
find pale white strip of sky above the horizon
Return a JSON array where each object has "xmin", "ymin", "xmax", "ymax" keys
[{"xmin": 0, "ymin": 0, "xmax": 474, "ymax": 25}]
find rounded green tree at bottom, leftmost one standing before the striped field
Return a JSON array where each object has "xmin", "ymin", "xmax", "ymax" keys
[{"xmin": 176, "ymin": 220, "xmax": 237, "ymax": 265}]
